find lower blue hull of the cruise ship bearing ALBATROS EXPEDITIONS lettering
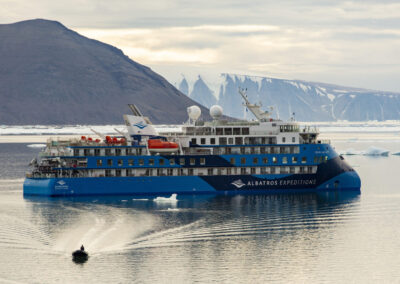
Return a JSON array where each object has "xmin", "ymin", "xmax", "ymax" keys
[{"xmin": 24, "ymin": 171, "xmax": 361, "ymax": 196}]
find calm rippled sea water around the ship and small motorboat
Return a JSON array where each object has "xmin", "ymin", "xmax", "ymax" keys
[{"xmin": 0, "ymin": 136, "xmax": 400, "ymax": 283}]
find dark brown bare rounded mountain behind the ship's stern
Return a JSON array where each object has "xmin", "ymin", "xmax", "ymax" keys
[{"xmin": 0, "ymin": 20, "xmax": 208, "ymax": 124}]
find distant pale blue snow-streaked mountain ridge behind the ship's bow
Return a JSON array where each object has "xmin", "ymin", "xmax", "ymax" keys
[{"xmin": 178, "ymin": 74, "xmax": 400, "ymax": 121}]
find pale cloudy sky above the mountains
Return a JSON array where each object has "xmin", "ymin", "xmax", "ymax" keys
[{"xmin": 0, "ymin": 0, "xmax": 400, "ymax": 92}]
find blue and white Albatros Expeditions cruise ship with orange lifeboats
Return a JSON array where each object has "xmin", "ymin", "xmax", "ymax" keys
[{"xmin": 24, "ymin": 90, "xmax": 361, "ymax": 196}]
